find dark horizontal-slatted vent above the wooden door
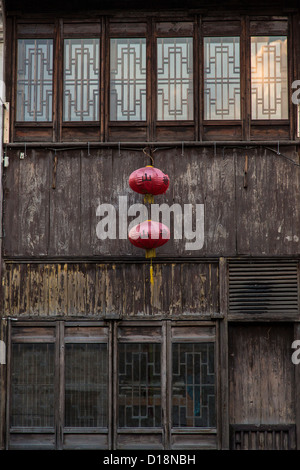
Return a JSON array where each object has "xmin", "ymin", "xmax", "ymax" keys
[{"xmin": 229, "ymin": 260, "xmax": 298, "ymax": 315}]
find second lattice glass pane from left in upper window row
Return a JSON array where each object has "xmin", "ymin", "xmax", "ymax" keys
[{"xmin": 64, "ymin": 39, "xmax": 100, "ymax": 121}]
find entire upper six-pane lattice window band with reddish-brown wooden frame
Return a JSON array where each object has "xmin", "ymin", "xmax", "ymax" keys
[{"xmin": 10, "ymin": 14, "xmax": 297, "ymax": 142}]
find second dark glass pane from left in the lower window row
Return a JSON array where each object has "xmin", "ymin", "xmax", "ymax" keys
[{"xmin": 65, "ymin": 344, "xmax": 108, "ymax": 428}]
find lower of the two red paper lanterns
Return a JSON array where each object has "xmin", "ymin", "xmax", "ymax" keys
[{"xmin": 128, "ymin": 220, "xmax": 170, "ymax": 258}]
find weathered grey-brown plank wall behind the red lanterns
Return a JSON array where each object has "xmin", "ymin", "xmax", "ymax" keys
[{"xmin": 3, "ymin": 146, "xmax": 300, "ymax": 259}]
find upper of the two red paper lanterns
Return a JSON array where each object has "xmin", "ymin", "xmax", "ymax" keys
[{"xmin": 129, "ymin": 165, "xmax": 170, "ymax": 202}]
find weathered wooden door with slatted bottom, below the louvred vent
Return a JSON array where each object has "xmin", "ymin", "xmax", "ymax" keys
[{"xmin": 229, "ymin": 323, "xmax": 295, "ymax": 449}]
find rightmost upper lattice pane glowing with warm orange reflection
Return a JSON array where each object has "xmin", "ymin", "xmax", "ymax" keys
[{"xmin": 251, "ymin": 36, "xmax": 288, "ymax": 119}]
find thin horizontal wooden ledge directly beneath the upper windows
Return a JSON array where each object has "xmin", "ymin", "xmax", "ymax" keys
[{"xmin": 3, "ymin": 139, "xmax": 300, "ymax": 151}]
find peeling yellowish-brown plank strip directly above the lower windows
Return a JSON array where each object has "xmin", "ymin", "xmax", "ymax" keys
[{"xmin": 3, "ymin": 263, "xmax": 219, "ymax": 319}]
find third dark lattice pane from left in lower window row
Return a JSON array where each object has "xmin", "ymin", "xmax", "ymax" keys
[{"xmin": 118, "ymin": 343, "xmax": 161, "ymax": 428}]
